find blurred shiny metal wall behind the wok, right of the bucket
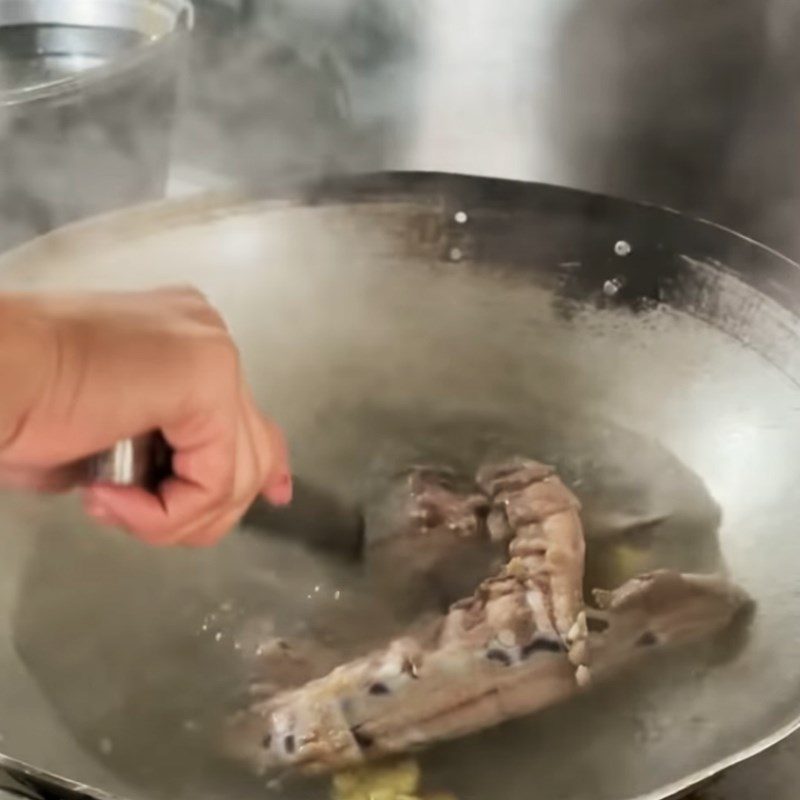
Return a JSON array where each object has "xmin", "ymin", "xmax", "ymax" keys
[{"xmin": 181, "ymin": 0, "xmax": 800, "ymax": 258}]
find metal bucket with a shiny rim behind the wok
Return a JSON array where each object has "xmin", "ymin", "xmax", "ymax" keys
[{"xmin": 0, "ymin": 0, "xmax": 193, "ymax": 253}]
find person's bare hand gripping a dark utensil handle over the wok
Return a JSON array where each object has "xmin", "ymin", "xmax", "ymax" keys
[{"xmin": 0, "ymin": 288, "xmax": 292, "ymax": 546}]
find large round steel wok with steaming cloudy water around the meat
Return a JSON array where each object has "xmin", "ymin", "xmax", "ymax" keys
[{"xmin": 0, "ymin": 174, "xmax": 800, "ymax": 800}]
